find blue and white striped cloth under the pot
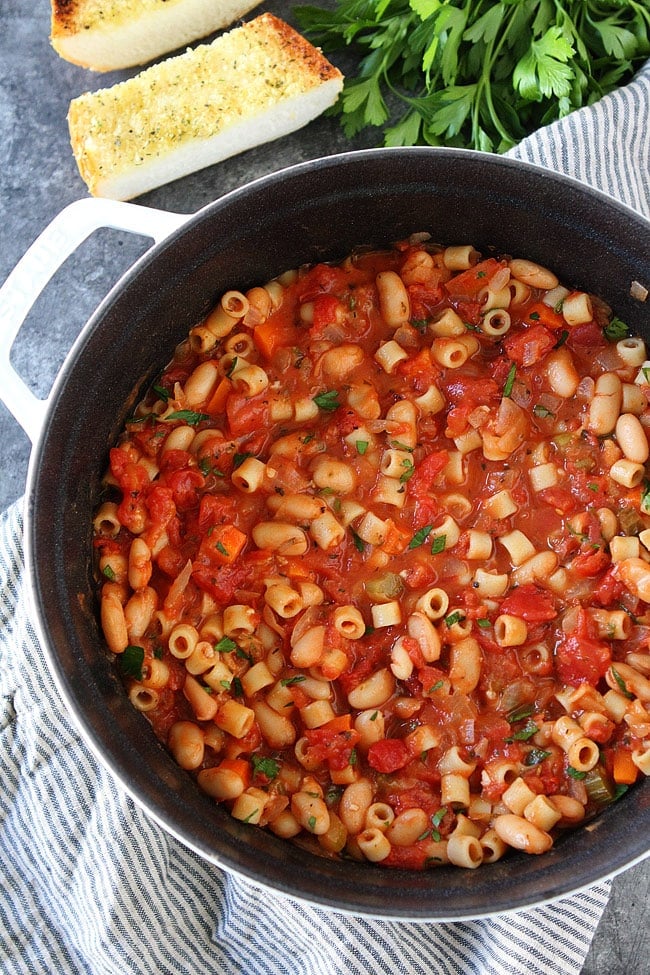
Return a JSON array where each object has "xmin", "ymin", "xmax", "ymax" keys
[{"xmin": 0, "ymin": 63, "xmax": 650, "ymax": 975}]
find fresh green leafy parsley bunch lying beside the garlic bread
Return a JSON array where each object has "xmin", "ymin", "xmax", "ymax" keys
[{"xmin": 295, "ymin": 0, "xmax": 650, "ymax": 152}]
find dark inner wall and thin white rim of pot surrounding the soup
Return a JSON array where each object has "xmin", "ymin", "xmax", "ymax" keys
[{"xmin": 26, "ymin": 149, "xmax": 650, "ymax": 920}]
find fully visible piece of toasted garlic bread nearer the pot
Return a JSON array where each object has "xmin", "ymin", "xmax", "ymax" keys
[{"xmin": 68, "ymin": 13, "xmax": 343, "ymax": 199}]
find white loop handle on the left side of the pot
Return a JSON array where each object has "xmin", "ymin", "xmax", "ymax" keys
[{"xmin": 0, "ymin": 198, "xmax": 189, "ymax": 443}]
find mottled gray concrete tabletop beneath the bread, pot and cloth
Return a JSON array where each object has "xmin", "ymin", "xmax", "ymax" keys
[{"xmin": 0, "ymin": 0, "xmax": 650, "ymax": 975}]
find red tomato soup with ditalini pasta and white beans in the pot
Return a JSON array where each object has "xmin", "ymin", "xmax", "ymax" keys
[{"xmin": 93, "ymin": 234, "xmax": 650, "ymax": 869}]
